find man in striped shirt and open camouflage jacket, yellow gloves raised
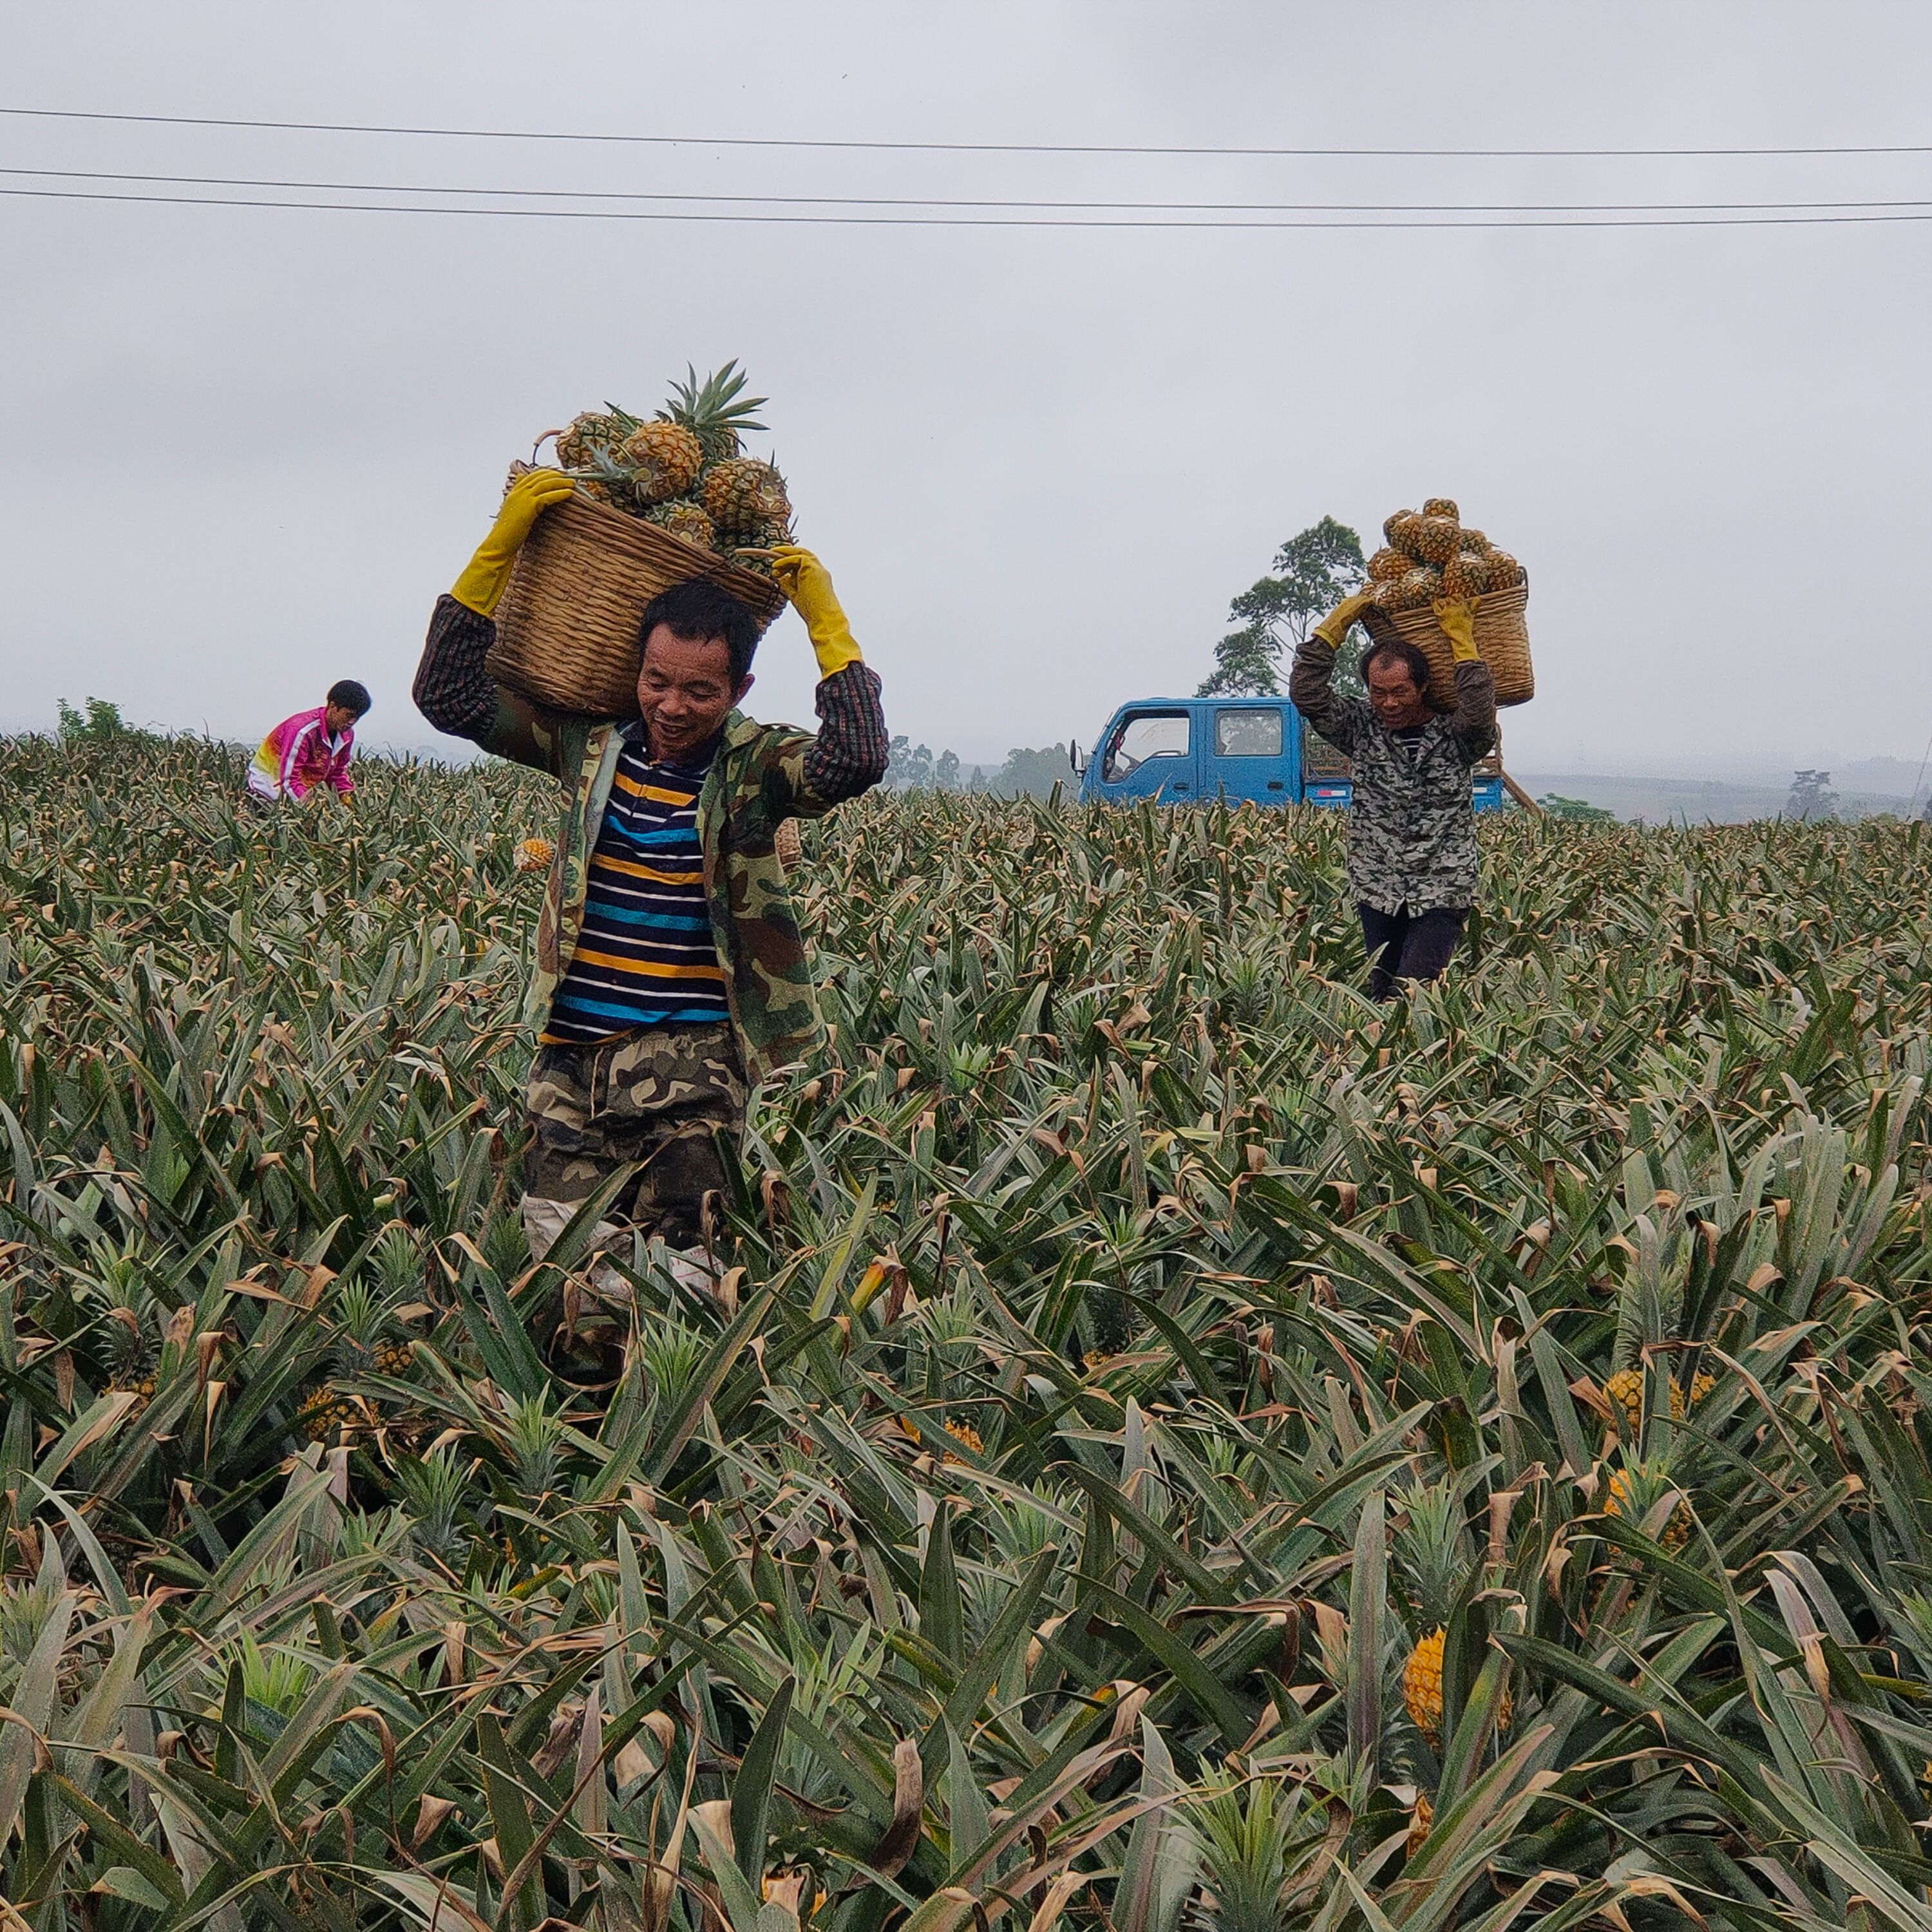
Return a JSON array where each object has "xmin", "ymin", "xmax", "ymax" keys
[{"xmin": 415, "ymin": 469, "xmax": 889, "ymax": 1289}]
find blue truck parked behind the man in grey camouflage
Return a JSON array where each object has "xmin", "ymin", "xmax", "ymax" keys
[{"xmin": 1072, "ymin": 697, "xmax": 1503, "ymax": 811}]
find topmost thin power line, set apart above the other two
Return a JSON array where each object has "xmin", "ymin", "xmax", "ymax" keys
[{"xmin": 0, "ymin": 106, "xmax": 1932, "ymax": 160}]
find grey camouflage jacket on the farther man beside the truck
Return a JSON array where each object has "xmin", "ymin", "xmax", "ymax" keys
[{"xmin": 1289, "ymin": 638, "xmax": 1495, "ymax": 912}]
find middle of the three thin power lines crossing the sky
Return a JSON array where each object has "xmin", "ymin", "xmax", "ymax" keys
[{"xmin": 11, "ymin": 168, "xmax": 1932, "ymax": 214}]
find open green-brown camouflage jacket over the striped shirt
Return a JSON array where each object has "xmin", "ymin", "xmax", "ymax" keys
[{"xmin": 415, "ymin": 597, "xmax": 887, "ymax": 1082}]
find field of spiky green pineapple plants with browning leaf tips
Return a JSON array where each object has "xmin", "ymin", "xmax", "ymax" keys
[{"xmin": 11, "ymin": 730, "xmax": 1932, "ymax": 1932}]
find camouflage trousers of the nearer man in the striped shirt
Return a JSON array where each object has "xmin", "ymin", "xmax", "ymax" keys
[{"xmin": 524, "ymin": 1026, "xmax": 746, "ymax": 1248}]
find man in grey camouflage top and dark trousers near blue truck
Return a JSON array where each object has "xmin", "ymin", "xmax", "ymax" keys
[{"xmin": 1289, "ymin": 591, "xmax": 1495, "ymax": 999}]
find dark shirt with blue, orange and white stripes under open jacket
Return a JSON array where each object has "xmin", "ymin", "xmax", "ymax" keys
[{"xmin": 543, "ymin": 732, "xmax": 730, "ymax": 1045}]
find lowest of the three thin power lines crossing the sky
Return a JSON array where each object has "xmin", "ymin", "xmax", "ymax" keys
[{"xmin": 15, "ymin": 187, "xmax": 1932, "ymax": 232}]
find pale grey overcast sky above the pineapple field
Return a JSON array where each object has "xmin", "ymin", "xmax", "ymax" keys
[{"xmin": 0, "ymin": 0, "xmax": 1932, "ymax": 771}]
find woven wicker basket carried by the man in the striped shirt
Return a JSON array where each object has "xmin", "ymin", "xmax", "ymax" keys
[{"xmin": 487, "ymin": 497, "xmax": 784, "ymax": 717}]
